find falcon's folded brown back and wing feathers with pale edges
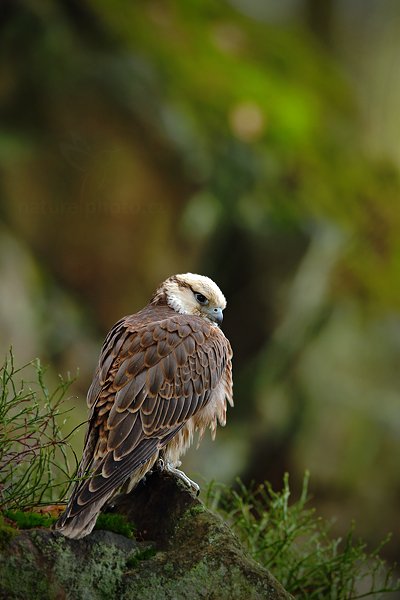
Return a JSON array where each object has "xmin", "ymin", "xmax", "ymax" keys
[{"xmin": 59, "ymin": 309, "xmax": 228, "ymax": 519}]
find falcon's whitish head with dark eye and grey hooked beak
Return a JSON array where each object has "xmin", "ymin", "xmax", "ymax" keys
[{"xmin": 152, "ymin": 273, "xmax": 226, "ymax": 325}]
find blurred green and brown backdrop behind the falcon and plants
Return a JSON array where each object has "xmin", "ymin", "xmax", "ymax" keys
[{"xmin": 0, "ymin": 0, "xmax": 400, "ymax": 559}]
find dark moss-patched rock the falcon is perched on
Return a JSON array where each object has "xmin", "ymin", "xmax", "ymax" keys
[{"xmin": 0, "ymin": 473, "xmax": 291, "ymax": 600}]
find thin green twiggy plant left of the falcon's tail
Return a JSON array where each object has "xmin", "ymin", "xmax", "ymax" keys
[{"xmin": 0, "ymin": 351, "xmax": 78, "ymax": 510}]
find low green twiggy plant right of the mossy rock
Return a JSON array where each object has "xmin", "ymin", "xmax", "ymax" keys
[{"xmin": 207, "ymin": 474, "xmax": 400, "ymax": 600}]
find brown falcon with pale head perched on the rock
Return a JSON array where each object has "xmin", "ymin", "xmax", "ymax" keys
[{"xmin": 56, "ymin": 273, "xmax": 233, "ymax": 538}]
